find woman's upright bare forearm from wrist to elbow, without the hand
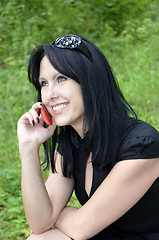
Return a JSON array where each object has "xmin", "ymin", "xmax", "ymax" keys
[{"xmin": 20, "ymin": 145, "xmax": 53, "ymax": 233}]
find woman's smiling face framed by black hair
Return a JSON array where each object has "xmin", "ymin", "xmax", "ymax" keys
[{"xmin": 39, "ymin": 56, "xmax": 84, "ymax": 135}]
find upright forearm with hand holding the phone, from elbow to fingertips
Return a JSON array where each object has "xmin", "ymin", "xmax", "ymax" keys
[{"xmin": 17, "ymin": 102, "xmax": 58, "ymax": 233}]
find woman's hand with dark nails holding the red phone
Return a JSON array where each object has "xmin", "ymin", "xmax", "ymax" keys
[{"xmin": 17, "ymin": 102, "xmax": 56, "ymax": 148}]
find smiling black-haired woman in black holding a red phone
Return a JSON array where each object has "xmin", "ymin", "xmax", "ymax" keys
[{"xmin": 18, "ymin": 35, "xmax": 159, "ymax": 240}]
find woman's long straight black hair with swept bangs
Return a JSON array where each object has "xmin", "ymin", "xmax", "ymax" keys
[{"xmin": 28, "ymin": 37, "xmax": 137, "ymax": 177}]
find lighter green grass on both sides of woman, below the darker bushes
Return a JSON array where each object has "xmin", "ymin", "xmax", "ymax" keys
[{"xmin": 0, "ymin": 35, "xmax": 159, "ymax": 240}]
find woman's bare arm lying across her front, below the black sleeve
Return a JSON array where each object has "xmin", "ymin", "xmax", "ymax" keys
[{"xmin": 55, "ymin": 158, "xmax": 159, "ymax": 240}]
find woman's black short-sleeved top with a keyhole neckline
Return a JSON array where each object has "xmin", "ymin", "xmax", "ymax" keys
[{"xmin": 58, "ymin": 120, "xmax": 159, "ymax": 240}]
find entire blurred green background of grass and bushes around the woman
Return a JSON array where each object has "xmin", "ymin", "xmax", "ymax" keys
[{"xmin": 0, "ymin": 0, "xmax": 159, "ymax": 240}]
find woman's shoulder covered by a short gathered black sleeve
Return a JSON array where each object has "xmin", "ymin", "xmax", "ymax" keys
[{"xmin": 119, "ymin": 120, "xmax": 159, "ymax": 161}]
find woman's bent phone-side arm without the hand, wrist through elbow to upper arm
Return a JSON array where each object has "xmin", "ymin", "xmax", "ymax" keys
[{"xmin": 21, "ymin": 148, "xmax": 74, "ymax": 234}]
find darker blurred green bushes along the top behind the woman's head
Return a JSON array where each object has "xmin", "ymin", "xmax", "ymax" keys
[{"xmin": 0, "ymin": 0, "xmax": 159, "ymax": 66}]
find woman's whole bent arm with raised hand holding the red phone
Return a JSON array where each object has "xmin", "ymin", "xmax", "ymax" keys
[{"xmin": 18, "ymin": 103, "xmax": 74, "ymax": 234}]
